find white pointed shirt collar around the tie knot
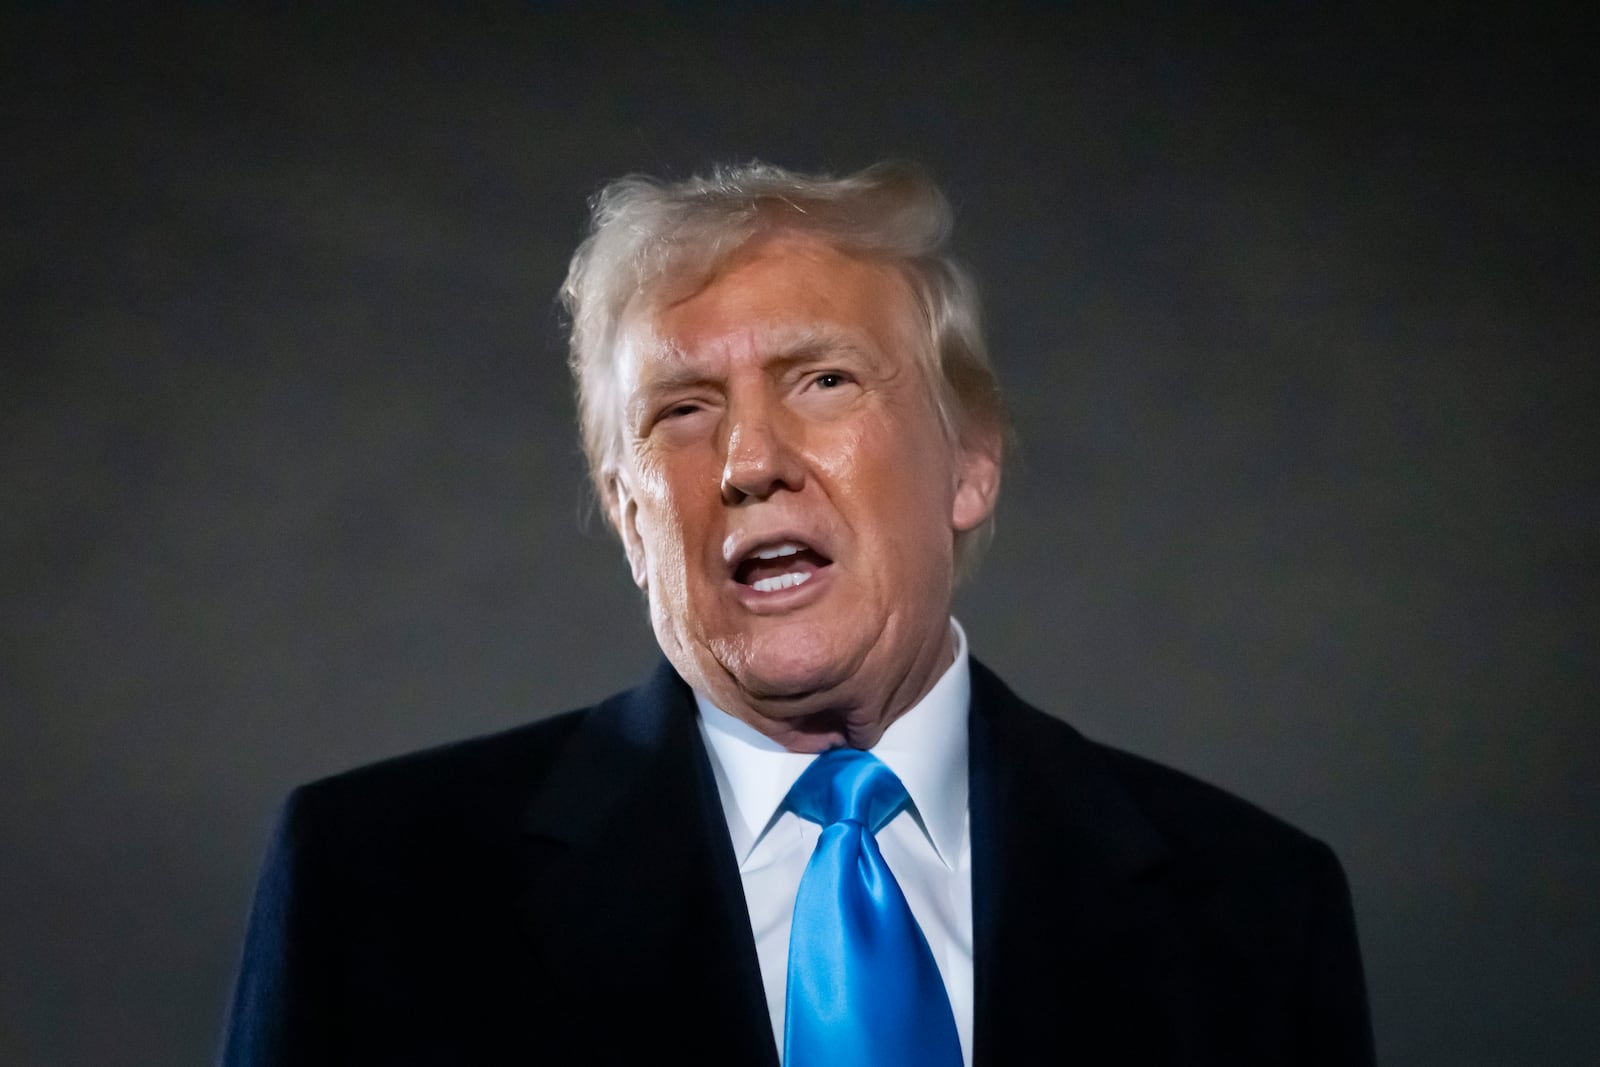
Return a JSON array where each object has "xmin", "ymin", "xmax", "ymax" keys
[{"xmin": 694, "ymin": 619, "xmax": 971, "ymax": 870}]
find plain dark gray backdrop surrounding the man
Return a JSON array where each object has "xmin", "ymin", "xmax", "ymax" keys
[{"xmin": 0, "ymin": 5, "xmax": 1600, "ymax": 1065}]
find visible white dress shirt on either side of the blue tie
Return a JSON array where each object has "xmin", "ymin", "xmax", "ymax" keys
[{"xmin": 694, "ymin": 619, "xmax": 973, "ymax": 1064}]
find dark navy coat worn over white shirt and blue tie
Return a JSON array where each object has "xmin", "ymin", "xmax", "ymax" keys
[{"xmin": 222, "ymin": 661, "xmax": 1373, "ymax": 1067}]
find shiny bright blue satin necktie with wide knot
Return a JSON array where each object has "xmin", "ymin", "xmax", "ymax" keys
[{"xmin": 784, "ymin": 749, "xmax": 962, "ymax": 1067}]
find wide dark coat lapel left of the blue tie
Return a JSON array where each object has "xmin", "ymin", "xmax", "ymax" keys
[{"xmin": 523, "ymin": 664, "xmax": 776, "ymax": 1067}]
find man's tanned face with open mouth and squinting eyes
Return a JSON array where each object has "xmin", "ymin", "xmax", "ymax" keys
[{"xmin": 606, "ymin": 234, "xmax": 998, "ymax": 750}]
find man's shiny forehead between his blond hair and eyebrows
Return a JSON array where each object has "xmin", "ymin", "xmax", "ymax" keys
[{"xmin": 619, "ymin": 234, "xmax": 920, "ymax": 382}]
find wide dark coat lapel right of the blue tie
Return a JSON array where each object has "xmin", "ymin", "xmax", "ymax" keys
[{"xmin": 970, "ymin": 661, "xmax": 1194, "ymax": 1065}]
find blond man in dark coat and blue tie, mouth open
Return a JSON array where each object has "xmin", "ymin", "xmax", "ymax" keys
[{"xmin": 222, "ymin": 165, "xmax": 1371, "ymax": 1067}]
